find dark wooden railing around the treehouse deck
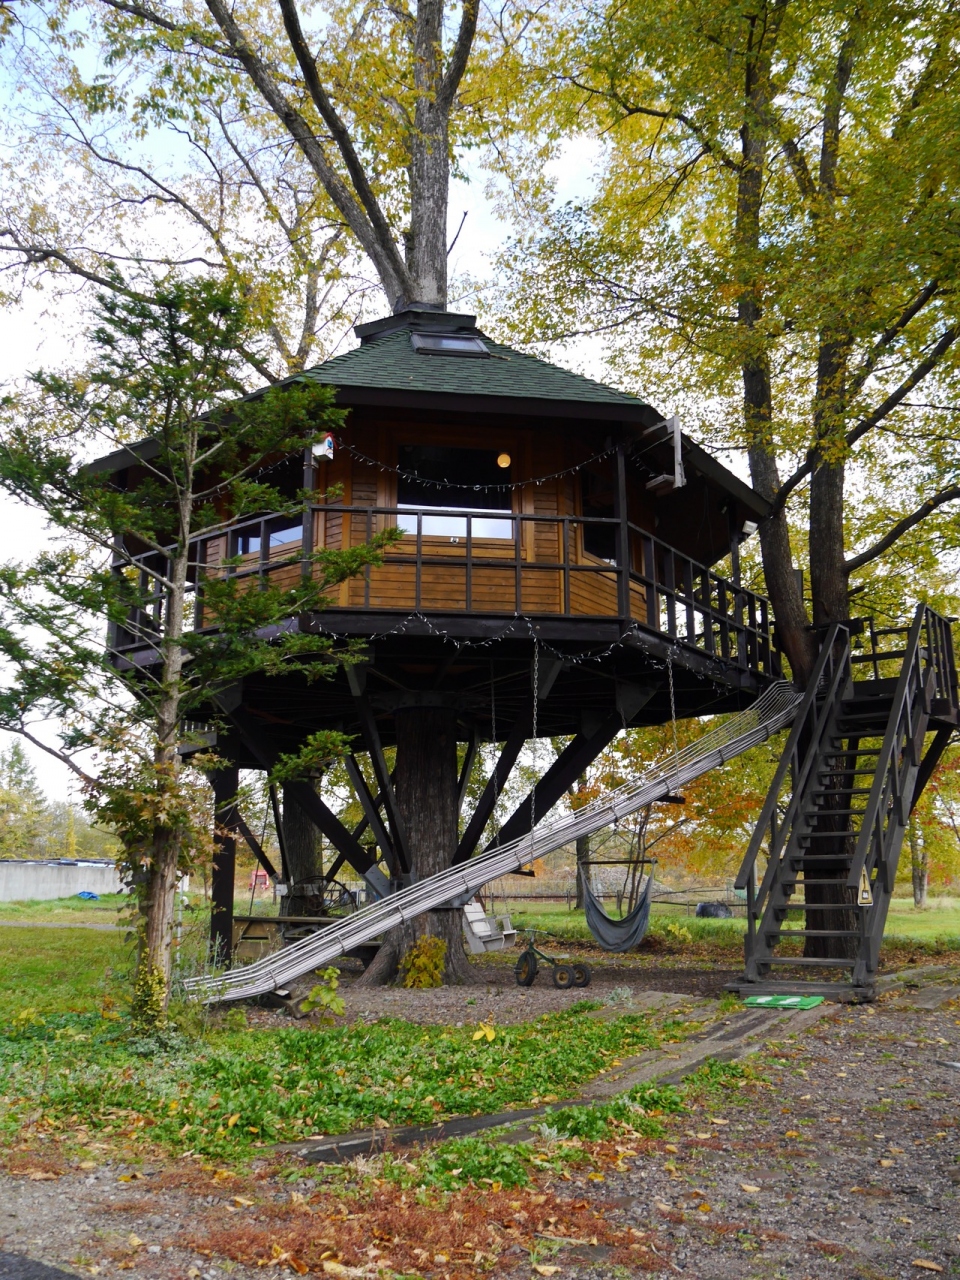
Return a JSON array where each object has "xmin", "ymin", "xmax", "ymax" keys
[{"xmin": 114, "ymin": 504, "xmax": 781, "ymax": 677}]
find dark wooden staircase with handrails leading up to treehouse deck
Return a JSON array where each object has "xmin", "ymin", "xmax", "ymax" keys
[{"xmin": 736, "ymin": 605, "xmax": 960, "ymax": 1000}]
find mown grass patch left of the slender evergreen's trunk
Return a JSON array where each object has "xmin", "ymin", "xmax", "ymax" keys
[{"xmin": 0, "ymin": 928, "xmax": 131, "ymax": 1024}]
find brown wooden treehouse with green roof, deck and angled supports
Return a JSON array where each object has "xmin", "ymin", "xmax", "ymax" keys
[{"xmin": 96, "ymin": 306, "xmax": 780, "ymax": 962}]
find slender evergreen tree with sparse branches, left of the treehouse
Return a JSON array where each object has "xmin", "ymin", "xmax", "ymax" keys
[{"xmin": 0, "ymin": 279, "xmax": 394, "ymax": 1016}]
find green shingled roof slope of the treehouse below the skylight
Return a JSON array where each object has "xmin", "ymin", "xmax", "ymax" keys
[{"xmin": 305, "ymin": 328, "xmax": 644, "ymax": 410}]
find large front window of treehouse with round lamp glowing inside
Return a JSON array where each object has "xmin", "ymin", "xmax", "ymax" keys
[{"xmin": 397, "ymin": 444, "xmax": 513, "ymax": 538}]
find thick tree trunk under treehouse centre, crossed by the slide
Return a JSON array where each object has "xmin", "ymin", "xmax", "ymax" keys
[{"xmin": 360, "ymin": 707, "xmax": 472, "ymax": 986}]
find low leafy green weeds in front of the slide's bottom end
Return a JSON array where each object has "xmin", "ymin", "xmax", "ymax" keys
[{"xmin": 0, "ymin": 1009, "xmax": 660, "ymax": 1158}]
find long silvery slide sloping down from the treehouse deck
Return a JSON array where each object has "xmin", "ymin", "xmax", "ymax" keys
[{"xmin": 184, "ymin": 681, "xmax": 803, "ymax": 1004}]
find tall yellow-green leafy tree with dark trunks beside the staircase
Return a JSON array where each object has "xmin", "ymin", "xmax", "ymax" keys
[{"xmin": 496, "ymin": 0, "xmax": 960, "ymax": 681}]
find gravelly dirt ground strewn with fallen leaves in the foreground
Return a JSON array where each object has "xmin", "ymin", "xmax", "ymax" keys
[{"xmin": 0, "ymin": 972, "xmax": 960, "ymax": 1280}]
